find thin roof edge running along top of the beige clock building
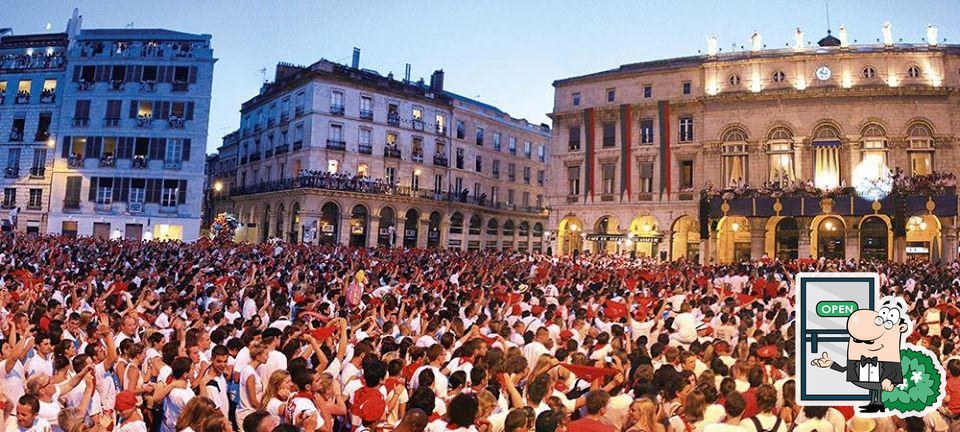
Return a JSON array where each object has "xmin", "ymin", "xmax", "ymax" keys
[{"xmin": 553, "ymin": 42, "xmax": 960, "ymax": 87}]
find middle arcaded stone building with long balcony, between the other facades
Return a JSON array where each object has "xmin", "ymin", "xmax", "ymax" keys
[{"xmin": 221, "ymin": 51, "xmax": 550, "ymax": 251}]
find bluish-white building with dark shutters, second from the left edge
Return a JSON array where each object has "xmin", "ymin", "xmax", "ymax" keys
[{"xmin": 47, "ymin": 12, "xmax": 216, "ymax": 241}]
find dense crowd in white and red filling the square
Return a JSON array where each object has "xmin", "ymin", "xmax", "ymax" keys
[{"xmin": 0, "ymin": 235, "xmax": 960, "ymax": 432}]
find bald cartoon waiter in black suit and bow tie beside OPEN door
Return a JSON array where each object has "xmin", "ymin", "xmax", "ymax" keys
[{"xmin": 813, "ymin": 296, "xmax": 913, "ymax": 413}]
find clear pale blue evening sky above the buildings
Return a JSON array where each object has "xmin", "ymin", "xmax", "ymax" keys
[{"xmin": 7, "ymin": 0, "xmax": 960, "ymax": 153}]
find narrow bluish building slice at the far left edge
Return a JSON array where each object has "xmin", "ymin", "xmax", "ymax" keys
[{"xmin": 0, "ymin": 33, "xmax": 68, "ymax": 233}]
